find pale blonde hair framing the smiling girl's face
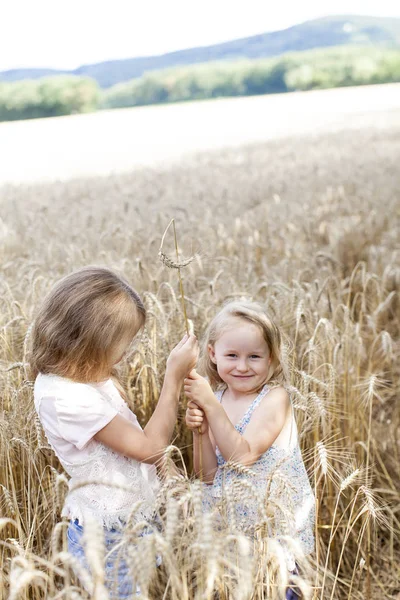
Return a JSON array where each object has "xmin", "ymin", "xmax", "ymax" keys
[{"xmin": 200, "ymin": 301, "xmax": 287, "ymax": 387}]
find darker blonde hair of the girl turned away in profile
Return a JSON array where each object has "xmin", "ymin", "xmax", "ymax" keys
[{"xmin": 30, "ymin": 267, "xmax": 146, "ymax": 383}]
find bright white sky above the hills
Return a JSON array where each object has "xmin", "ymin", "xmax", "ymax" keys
[{"xmin": 0, "ymin": 0, "xmax": 400, "ymax": 71}]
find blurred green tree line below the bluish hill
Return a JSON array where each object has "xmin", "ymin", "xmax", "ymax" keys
[{"xmin": 0, "ymin": 46, "xmax": 400, "ymax": 121}]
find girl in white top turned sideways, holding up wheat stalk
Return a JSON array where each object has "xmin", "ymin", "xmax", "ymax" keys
[{"xmin": 30, "ymin": 267, "xmax": 198, "ymax": 598}]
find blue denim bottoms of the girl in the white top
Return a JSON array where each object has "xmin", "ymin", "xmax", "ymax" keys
[{"xmin": 67, "ymin": 520, "xmax": 140, "ymax": 600}]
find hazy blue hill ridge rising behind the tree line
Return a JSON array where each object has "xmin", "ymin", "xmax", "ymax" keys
[{"xmin": 0, "ymin": 15, "xmax": 400, "ymax": 88}]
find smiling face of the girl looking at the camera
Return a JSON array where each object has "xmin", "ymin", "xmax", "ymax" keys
[{"xmin": 208, "ymin": 318, "xmax": 271, "ymax": 393}]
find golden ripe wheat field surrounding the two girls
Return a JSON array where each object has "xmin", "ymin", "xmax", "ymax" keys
[{"xmin": 0, "ymin": 115, "xmax": 400, "ymax": 600}]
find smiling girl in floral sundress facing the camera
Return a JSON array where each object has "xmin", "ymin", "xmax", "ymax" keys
[{"xmin": 184, "ymin": 302, "xmax": 315, "ymax": 599}]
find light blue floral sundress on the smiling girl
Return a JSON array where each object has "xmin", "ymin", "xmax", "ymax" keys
[{"xmin": 203, "ymin": 385, "xmax": 315, "ymax": 570}]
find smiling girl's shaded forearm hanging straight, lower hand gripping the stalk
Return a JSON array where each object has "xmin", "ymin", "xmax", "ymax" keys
[{"xmin": 186, "ymin": 402, "xmax": 218, "ymax": 483}]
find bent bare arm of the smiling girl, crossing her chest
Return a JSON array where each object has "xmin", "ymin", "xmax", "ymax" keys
[{"xmin": 185, "ymin": 371, "xmax": 290, "ymax": 465}]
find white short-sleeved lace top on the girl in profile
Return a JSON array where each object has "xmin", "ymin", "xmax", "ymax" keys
[{"xmin": 34, "ymin": 373, "xmax": 158, "ymax": 529}]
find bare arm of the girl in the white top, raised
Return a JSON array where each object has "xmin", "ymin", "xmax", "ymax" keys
[{"xmin": 94, "ymin": 336, "xmax": 198, "ymax": 463}]
